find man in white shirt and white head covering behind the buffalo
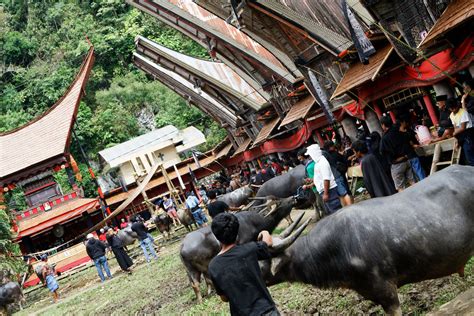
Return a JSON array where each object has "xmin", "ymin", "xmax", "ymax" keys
[{"xmin": 306, "ymin": 144, "xmax": 342, "ymax": 214}]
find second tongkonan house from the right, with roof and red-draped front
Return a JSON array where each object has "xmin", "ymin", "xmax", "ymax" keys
[{"xmin": 187, "ymin": 0, "xmax": 364, "ymax": 143}]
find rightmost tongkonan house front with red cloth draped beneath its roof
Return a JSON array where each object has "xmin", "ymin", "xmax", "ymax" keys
[{"xmin": 332, "ymin": 0, "xmax": 474, "ymax": 139}]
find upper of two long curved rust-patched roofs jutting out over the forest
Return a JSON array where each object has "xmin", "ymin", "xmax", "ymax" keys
[{"xmin": 128, "ymin": 0, "xmax": 300, "ymax": 87}]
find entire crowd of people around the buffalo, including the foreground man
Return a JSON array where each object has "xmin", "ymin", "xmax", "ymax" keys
[{"xmin": 41, "ymin": 84, "xmax": 474, "ymax": 308}]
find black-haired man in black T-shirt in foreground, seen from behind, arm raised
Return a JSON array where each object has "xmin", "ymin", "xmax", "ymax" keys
[{"xmin": 209, "ymin": 213, "xmax": 279, "ymax": 315}]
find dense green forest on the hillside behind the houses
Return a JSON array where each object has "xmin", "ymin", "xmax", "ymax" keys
[{"xmin": 0, "ymin": 0, "xmax": 225, "ymax": 270}]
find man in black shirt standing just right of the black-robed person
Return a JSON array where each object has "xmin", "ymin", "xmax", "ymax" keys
[{"xmin": 380, "ymin": 116, "xmax": 415, "ymax": 192}]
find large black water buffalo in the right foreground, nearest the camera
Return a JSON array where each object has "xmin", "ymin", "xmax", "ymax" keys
[{"xmin": 262, "ymin": 166, "xmax": 474, "ymax": 315}]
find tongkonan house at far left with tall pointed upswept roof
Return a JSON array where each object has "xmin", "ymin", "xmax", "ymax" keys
[{"xmin": 0, "ymin": 47, "xmax": 103, "ymax": 285}]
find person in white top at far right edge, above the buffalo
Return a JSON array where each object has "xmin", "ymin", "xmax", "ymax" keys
[{"xmin": 446, "ymin": 98, "xmax": 474, "ymax": 166}]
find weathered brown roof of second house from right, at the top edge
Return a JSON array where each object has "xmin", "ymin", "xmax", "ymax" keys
[{"xmin": 195, "ymin": 0, "xmax": 352, "ymax": 56}]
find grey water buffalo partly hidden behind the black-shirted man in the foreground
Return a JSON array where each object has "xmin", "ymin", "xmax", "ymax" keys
[{"xmin": 180, "ymin": 197, "xmax": 295, "ymax": 301}]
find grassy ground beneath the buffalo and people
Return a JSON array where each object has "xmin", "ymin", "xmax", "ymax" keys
[{"xmin": 17, "ymin": 220, "xmax": 474, "ymax": 315}]
